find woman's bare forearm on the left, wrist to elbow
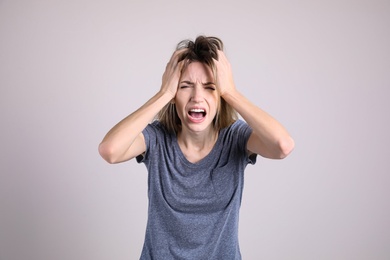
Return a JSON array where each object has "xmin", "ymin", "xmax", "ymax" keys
[{"xmin": 99, "ymin": 91, "xmax": 172, "ymax": 162}]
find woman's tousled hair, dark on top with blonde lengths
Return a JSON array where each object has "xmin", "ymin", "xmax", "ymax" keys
[{"xmin": 156, "ymin": 36, "xmax": 238, "ymax": 134}]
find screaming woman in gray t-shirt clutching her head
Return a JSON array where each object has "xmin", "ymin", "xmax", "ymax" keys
[{"xmin": 99, "ymin": 36, "xmax": 294, "ymax": 260}]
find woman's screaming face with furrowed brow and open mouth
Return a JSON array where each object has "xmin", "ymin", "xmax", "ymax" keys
[{"xmin": 175, "ymin": 62, "xmax": 219, "ymax": 132}]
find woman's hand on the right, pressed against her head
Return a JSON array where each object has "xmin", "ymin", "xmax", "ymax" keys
[{"xmin": 214, "ymin": 50, "xmax": 236, "ymax": 97}]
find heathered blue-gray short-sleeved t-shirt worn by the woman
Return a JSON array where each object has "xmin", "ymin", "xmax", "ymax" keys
[{"xmin": 137, "ymin": 120, "xmax": 256, "ymax": 260}]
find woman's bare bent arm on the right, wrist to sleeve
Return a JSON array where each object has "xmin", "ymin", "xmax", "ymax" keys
[{"xmin": 223, "ymin": 89, "xmax": 294, "ymax": 158}]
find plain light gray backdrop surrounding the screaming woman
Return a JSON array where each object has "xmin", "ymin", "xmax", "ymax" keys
[{"xmin": 0, "ymin": 0, "xmax": 390, "ymax": 260}]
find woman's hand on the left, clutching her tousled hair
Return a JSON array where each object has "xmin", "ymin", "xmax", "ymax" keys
[{"xmin": 161, "ymin": 48, "xmax": 186, "ymax": 98}]
